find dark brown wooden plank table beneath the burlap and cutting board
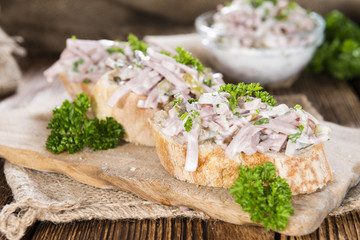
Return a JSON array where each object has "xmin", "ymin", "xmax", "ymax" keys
[{"xmin": 0, "ymin": 59, "xmax": 360, "ymax": 240}]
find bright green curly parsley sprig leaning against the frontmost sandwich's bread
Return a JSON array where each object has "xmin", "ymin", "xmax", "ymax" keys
[{"xmin": 230, "ymin": 162, "xmax": 294, "ymax": 231}]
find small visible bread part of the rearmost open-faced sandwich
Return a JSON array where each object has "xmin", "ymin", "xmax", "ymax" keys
[{"xmin": 59, "ymin": 73, "xmax": 96, "ymax": 100}]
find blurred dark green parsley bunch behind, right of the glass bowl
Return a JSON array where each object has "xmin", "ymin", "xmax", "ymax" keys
[{"xmin": 307, "ymin": 11, "xmax": 360, "ymax": 80}]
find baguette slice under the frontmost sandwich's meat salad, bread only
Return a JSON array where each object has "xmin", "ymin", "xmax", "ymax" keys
[{"xmin": 151, "ymin": 111, "xmax": 333, "ymax": 195}]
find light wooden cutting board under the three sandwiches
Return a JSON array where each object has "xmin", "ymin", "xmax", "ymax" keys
[{"xmin": 0, "ymin": 78, "xmax": 360, "ymax": 235}]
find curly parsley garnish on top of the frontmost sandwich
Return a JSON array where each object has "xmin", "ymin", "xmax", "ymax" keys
[{"xmin": 219, "ymin": 83, "xmax": 275, "ymax": 113}]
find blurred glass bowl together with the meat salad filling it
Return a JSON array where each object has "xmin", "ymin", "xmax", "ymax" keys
[{"xmin": 195, "ymin": 0, "xmax": 325, "ymax": 87}]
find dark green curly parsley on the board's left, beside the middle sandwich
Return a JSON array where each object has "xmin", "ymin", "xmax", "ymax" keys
[{"xmin": 46, "ymin": 93, "xmax": 124, "ymax": 153}]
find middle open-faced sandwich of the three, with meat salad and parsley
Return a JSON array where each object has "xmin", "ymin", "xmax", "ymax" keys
[{"xmin": 92, "ymin": 42, "xmax": 223, "ymax": 146}]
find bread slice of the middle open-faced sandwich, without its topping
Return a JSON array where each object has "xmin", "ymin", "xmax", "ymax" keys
[{"xmin": 91, "ymin": 70, "xmax": 159, "ymax": 146}]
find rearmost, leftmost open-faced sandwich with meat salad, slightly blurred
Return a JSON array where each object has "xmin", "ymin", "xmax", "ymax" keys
[{"xmin": 44, "ymin": 34, "xmax": 137, "ymax": 99}]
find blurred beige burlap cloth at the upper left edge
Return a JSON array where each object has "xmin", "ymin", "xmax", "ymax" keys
[{"xmin": 0, "ymin": 28, "xmax": 25, "ymax": 96}]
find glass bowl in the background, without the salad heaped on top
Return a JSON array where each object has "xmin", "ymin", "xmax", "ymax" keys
[{"xmin": 195, "ymin": 11, "xmax": 325, "ymax": 87}]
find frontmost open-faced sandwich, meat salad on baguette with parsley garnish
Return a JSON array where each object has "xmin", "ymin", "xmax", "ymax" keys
[{"xmin": 152, "ymin": 83, "xmax": 333, "ymax": 195}]
